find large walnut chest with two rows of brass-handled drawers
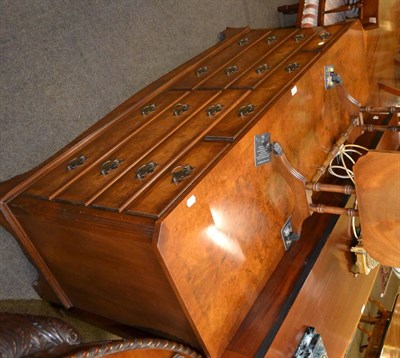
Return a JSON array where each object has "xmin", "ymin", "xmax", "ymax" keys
[{"xmin": 0, "ymin": 22, "xmax": 390, "ymax": 357}]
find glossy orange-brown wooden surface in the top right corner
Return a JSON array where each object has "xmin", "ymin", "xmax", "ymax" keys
[{"xmin": 365, "ymin": 0, "xmax": 400, "ymax": 105}]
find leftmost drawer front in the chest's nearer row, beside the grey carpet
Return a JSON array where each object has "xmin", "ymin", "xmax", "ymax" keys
[{"xmin": 27, "ymin": 92, "xmax": 187, "ymax": 198}]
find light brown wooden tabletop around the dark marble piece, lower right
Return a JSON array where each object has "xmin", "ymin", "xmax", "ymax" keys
[{"xmin": 265, "ymin": 197, "xmax": 378, "ymax": 358}]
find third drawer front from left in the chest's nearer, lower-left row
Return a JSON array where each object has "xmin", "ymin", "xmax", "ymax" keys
[{"xmin": 90, "ymin": 91, "xmax": 248, "ymax": 211}]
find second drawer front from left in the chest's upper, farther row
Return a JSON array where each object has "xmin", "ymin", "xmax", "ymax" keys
[{"xmin": 196, "ymin": 29, "xmax": 300, "ymax": 89}]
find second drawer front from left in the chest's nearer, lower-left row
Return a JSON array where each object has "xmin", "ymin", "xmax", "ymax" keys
[{"xmin": 54, "ymin": 91, "xmax": 238, "ymax": 205}]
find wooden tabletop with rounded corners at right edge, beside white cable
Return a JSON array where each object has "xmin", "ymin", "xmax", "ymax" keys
[{"xmin": 354, "ymin": 151, "xmax": 400, "ymax": 267}]
